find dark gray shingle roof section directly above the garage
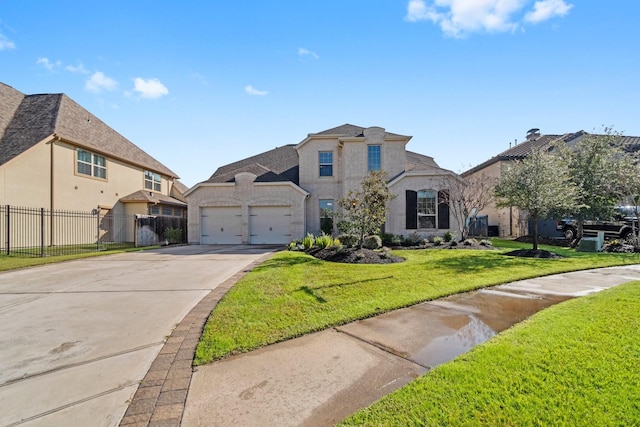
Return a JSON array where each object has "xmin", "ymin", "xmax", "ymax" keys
[{"xmin": 204, "ymin": 144, "xmax": 299, "ymax": 184}]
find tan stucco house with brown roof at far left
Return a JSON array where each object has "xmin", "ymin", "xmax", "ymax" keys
[{"xmin": 0, "ymin": 83, "xmax": 187, "ymax": 239}]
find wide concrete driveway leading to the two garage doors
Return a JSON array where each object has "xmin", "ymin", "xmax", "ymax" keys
[{"xmin": 0, "ymin": 246, "xmax": 273, "ymax": 426}]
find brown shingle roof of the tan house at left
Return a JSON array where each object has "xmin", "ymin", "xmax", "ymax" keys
[{"xmin": 0, "ymin": 83, "xmax": 177, "ymax": 177}]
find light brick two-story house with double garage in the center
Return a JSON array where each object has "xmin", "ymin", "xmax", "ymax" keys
[{"xmin": 185, "ymin": 124, "xmax": 458, "ymax": 244}]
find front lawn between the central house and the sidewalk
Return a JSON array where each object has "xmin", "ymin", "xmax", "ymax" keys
[{"xmin": 194, "ymin": 239, "xmax": 640, "ymax": 365}]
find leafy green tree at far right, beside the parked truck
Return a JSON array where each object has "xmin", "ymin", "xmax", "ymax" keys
[{"xmin": 562, "ymin": 128, "xmax": 636, "ymax": 239}]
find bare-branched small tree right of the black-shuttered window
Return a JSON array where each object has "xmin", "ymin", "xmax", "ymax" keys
[{"xmin": 442, "ymin": 173, "xmax": 495, "ymax": 241}]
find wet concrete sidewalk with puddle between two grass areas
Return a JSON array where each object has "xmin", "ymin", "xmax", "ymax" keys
[{"xmin": 181, "ymin": 265, "xmax": 640, "ymax": 427}]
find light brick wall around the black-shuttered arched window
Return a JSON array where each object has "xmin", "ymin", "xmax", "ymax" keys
[{"xmin": 385, "ymin": 174, "xmax": 459, "ymax": 238}]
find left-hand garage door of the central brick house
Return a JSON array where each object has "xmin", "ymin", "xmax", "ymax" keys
[{"xmin": 200, "ymin": 206, "xmax": 242, "ymax": 245}]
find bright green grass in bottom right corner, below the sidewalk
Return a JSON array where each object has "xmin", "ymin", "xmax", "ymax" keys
[{"xmin": 342, "ymin": 282, "xmax": 640, "ymax": 427}]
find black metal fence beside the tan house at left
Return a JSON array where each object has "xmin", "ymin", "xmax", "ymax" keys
[{"xmin": 0, "ymin": 205, "xmax": 187, "ymax": 257}]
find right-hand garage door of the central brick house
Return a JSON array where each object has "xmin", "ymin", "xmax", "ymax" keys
[{"xmin": 249, "ymin": 206, "xmax": 291, "ymax": 244}]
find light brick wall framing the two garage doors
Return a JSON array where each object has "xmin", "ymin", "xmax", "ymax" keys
[{"xmin": 187, "ymin": 173, "xmax": 307, "ymax": 244}]
